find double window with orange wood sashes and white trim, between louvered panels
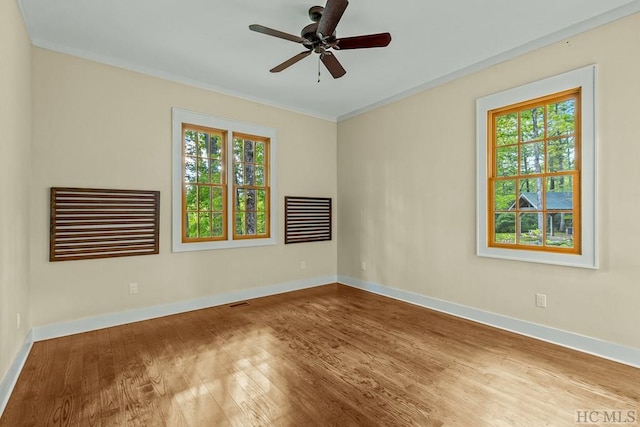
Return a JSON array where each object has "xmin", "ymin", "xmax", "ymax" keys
[{"xmin": 173, "ymin": 108, "xmax": 276, "ymax": 251}]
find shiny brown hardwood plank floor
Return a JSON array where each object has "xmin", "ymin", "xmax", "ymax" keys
[{"xmin": 0, "ymin": 284, "xmax": 640, "ymax": 427}]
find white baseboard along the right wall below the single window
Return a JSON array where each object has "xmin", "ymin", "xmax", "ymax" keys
[{"xmin": 338, "ymin": 276, "xmax": 640, "ymax": 368}]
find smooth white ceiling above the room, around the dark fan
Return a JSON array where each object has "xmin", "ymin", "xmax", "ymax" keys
[{"xmin": 18, "ymin": 0, "xmax": 640, "ymax": 120}]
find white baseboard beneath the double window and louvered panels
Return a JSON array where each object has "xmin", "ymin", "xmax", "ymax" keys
[{"xmin": 33, "ymin": 276, "xmax": 337, "ymax": 341}]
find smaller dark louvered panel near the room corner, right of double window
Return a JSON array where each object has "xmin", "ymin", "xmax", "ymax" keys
[{"xmin": 284, "ymin": 197, "xmax": 331, "ymax": 243}]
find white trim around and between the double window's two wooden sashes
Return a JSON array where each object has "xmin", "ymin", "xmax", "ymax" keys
[{"xmin": 171, "ymin": 108, "xmax": 278, "ymax": 252}]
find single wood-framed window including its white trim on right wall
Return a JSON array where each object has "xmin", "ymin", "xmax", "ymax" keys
[{"xmin": 477, "ymin": 66, "xmax": 597, "ymax": 268}]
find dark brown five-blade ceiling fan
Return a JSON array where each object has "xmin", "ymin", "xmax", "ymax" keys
[{"xmin": 249, "ymin": 0, "xmax": 391, "ymax": 79}]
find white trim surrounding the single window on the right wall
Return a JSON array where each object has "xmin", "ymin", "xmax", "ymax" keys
[{"xmin": 476, "ymin": 65, "xmax": 598, "ymax": 268}]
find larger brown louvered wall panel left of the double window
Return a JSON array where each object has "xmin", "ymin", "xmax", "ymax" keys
[{"xmin": 49, "ymin": 187, "xmax": 160, "ymax": 261}]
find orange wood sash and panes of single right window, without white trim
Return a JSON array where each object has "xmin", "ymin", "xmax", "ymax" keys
[{"xmin": 488, "ymin": 91, "xmax": 580, "ymax": 253}]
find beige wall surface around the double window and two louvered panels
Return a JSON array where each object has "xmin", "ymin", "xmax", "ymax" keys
[{"xmin": 31, "ymin": 48, "xmax": 337, "ymax": 326}]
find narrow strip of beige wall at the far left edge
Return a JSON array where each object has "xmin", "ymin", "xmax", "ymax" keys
[{"xmin": 0, "ymin": 0, "xmax": 31, "ymax": 380}]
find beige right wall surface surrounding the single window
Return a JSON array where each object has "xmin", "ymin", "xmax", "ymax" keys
[{"xmin": 338, "ymin": 14, "xmax": 640, "ymax": 348}]
